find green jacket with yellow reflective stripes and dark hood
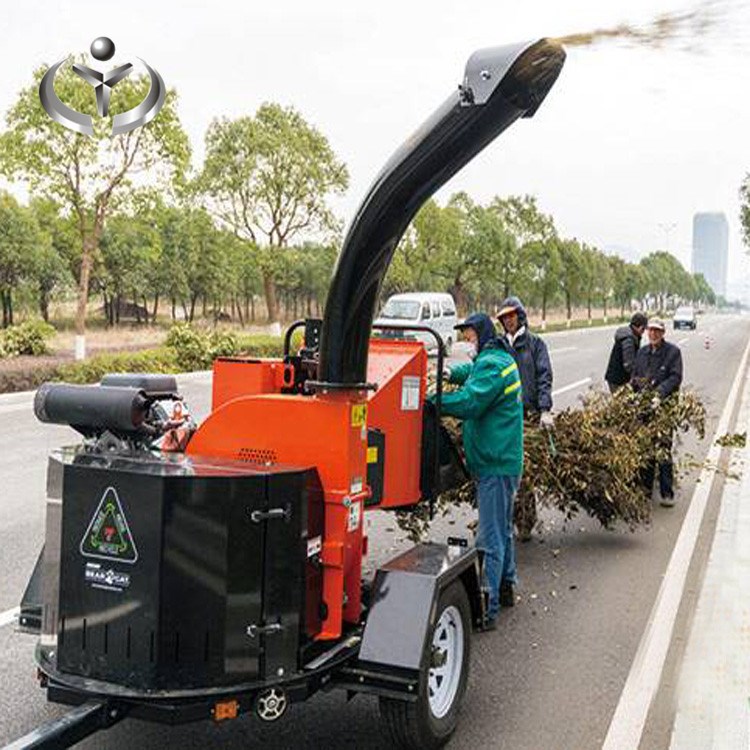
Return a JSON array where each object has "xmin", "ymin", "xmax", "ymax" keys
[{"xmin": 442, "ymin": 314, "xmax": 523, "ymax": 477}]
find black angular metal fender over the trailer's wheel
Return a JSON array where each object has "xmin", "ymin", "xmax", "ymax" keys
[{"xmin": 359, "ymin": 544, "xmax": 483, "ymax": 670}]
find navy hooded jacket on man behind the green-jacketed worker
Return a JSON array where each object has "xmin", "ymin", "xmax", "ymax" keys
[{"xmin": 498, "ymin": 297, "xmax": 552, "ymax": 412}]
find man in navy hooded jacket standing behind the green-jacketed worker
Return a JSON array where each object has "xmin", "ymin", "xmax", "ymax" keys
[{"xmin": 497, "ymin": 297, "xmax": 554, "ymax": 542}]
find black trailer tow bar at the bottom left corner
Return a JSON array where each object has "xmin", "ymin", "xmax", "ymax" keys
[{"xmin": 2, "ymin": 700, "xmax": 127, "ymax": 750}]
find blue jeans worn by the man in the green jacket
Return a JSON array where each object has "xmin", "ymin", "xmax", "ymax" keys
[{"xmin": 477, "ymin": 476, "xmax": 521, "ymax": 617}]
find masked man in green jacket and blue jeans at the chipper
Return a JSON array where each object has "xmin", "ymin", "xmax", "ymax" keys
[{"xmin": 432, "ymin": 313, "xmax": 523, "ymax": 630}]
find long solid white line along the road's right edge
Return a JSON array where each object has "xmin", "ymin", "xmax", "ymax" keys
[{"xmin": 602, "ymin": 334, "xmax": 750, "ymax": 750}]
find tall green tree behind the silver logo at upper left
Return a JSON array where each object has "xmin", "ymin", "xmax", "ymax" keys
[{"xmin": 0, "ymin": 60, "xmax": 190, "ymax": 346}]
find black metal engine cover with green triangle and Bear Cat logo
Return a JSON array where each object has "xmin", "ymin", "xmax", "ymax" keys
[{"xmin": 57, "ymin": 453, "xmax": 323, "ymax": 690}]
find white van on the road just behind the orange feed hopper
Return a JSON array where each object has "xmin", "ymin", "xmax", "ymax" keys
[{"xmin": 375, "ymin": 292, "xmax": 458, "ymax": 354}]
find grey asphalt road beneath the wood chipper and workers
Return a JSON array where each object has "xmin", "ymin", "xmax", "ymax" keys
[{"xmin": 0, "ymin": 317, "xmax": 750, "ymax": 750}]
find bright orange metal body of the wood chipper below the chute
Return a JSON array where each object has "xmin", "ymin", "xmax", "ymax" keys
[{"xmin": 187, "ymin": 339, "xmax": 427, "ymax": 639}]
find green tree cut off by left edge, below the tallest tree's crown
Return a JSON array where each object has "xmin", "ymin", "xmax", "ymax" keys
[{"xmin": 0, "ymin": 192, "xmax": 49, "ymax": 328}]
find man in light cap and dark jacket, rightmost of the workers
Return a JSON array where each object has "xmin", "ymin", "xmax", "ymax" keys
[{"xmin": 632, "ymin": 320, "xmax": 682, "ymax": 508}]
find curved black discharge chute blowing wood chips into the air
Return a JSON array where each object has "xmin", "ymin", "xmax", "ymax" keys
[{"xmin": 317, "ymin": 39, "xmax": 565, "ymax": 387}]
